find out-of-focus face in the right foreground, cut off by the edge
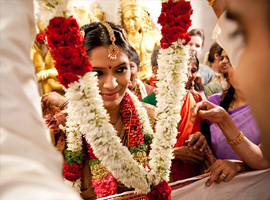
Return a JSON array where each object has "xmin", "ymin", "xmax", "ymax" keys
[{"xmin": 228, "ymin": 0, "xmax": 270, "ymax": 142}]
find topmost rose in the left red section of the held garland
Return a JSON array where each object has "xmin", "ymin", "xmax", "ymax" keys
[{"xmin": 47, "ymin": 17, "xmax": 69, "ymax": 35}]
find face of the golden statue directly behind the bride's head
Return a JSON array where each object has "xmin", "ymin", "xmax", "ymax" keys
[{"xmin": 123, "ymin": 9, "xmax": 142, "ymax": 33}]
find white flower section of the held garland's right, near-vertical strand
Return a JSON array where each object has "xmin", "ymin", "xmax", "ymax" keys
[{"xmin": 149, "ymin": 40, "xmax": 188, "ymax": 185}]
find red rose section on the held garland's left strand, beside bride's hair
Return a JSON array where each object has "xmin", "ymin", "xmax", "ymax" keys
[{"xmin": 45, "ymin": 17, "xmax": 92, "ymax": 88}]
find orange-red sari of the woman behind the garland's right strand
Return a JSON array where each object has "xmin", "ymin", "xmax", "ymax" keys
[{"xmin": 171, "ymin": 89, "xmax": 202, "ymax": 181}]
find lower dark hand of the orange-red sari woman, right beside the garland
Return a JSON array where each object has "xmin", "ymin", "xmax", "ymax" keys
[{"xmin": 173, "ymin": 146, "xmax": 204, "ymax": 165}]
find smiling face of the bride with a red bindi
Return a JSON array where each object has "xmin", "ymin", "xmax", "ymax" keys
[{"xmin": 89, "ymin": 47, "xmax": 130, "ymax": 109}]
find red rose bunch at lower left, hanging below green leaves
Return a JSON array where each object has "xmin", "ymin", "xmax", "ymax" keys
[{"xmin": 63, "ymin": 162, "xmax": 82, "ymax": 182}]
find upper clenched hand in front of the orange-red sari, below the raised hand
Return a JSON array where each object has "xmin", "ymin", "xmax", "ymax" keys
[{"xmin": 185, "ymin": 132, "xmax": 211, "ymax": 153}]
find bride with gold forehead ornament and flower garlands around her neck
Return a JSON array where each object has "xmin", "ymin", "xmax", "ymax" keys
[{"xmin": 41, "ymin": 22, "xmax": 154, "ymax": 199}]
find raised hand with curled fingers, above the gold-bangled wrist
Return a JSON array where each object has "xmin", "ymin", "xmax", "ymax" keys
[{"xmin": 190, "ymin": 100, "xmax": 229, "ymax": 123}]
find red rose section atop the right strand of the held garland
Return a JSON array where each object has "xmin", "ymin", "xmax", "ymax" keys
[{"xmin": 158, "ymin": 0, "xmax": 193, "ymax": 49}]
